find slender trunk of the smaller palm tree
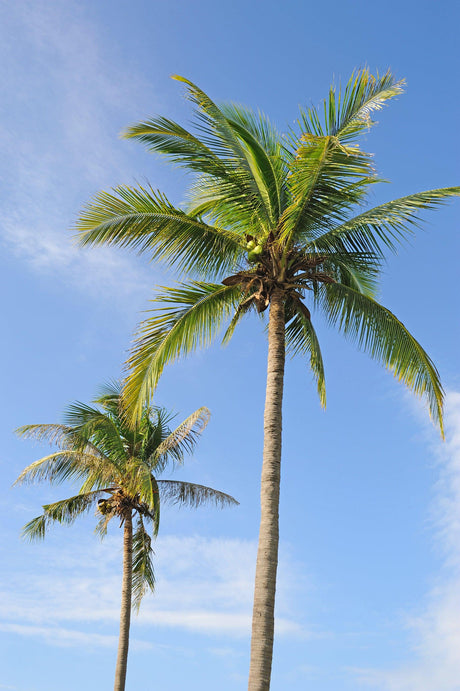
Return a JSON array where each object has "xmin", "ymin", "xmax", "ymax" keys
[{"xmin": 114, "ymin": 510, "xmax": 133, "ymax": 691}]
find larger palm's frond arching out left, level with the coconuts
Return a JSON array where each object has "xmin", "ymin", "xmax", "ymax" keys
[{"xmin": 76, "ymin": 186, "xmax": 244, "ymax": 282}]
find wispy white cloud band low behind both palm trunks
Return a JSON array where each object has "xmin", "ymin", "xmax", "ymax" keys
[{"xmin": 0, "ymin": 536, "xmax": 308, "ymax": 645}]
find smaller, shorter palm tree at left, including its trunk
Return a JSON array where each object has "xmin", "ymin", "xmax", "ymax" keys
[{"xmin": 16, "ymin": 384, "xmax": 238, "ymax": 691}]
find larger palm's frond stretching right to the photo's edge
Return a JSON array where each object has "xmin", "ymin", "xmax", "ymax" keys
[{"xmin": 308, "ymin": 187, "xmax": 460, "ymax": 256}]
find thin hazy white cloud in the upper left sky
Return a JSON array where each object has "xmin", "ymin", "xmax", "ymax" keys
[{"xmin": 0, "ymin": 0, "xmax": 162, "ymax": 297}]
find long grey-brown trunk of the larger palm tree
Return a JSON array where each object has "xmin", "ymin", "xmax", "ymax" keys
[{"xmin": 248, "ymin": 290, "xmax": 285, "ymax": 691}]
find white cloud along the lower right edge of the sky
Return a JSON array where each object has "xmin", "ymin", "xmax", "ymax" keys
[{"xmin": 354, "ymin": 392, "xmax": 460, "ymax": 691}]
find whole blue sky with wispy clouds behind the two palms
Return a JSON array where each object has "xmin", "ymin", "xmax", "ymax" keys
[{"xmin": 0, "ymin": 0, "xmax": 460, "ymax": 691}]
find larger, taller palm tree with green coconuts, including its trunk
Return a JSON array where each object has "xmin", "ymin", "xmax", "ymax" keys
[{"xmin": 77, "ymin": 70, "xmax": 460, "ymax": 691}]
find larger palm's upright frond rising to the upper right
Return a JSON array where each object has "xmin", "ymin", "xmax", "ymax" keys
[{"xmin": 281, "ymin": 70, "xmax": 408, "ymax": 246}]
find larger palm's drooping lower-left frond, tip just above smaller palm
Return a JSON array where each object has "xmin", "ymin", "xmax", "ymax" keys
[{"xmin": 125, "ymin": 282, "xmax": 241, "ymax": 416}]
